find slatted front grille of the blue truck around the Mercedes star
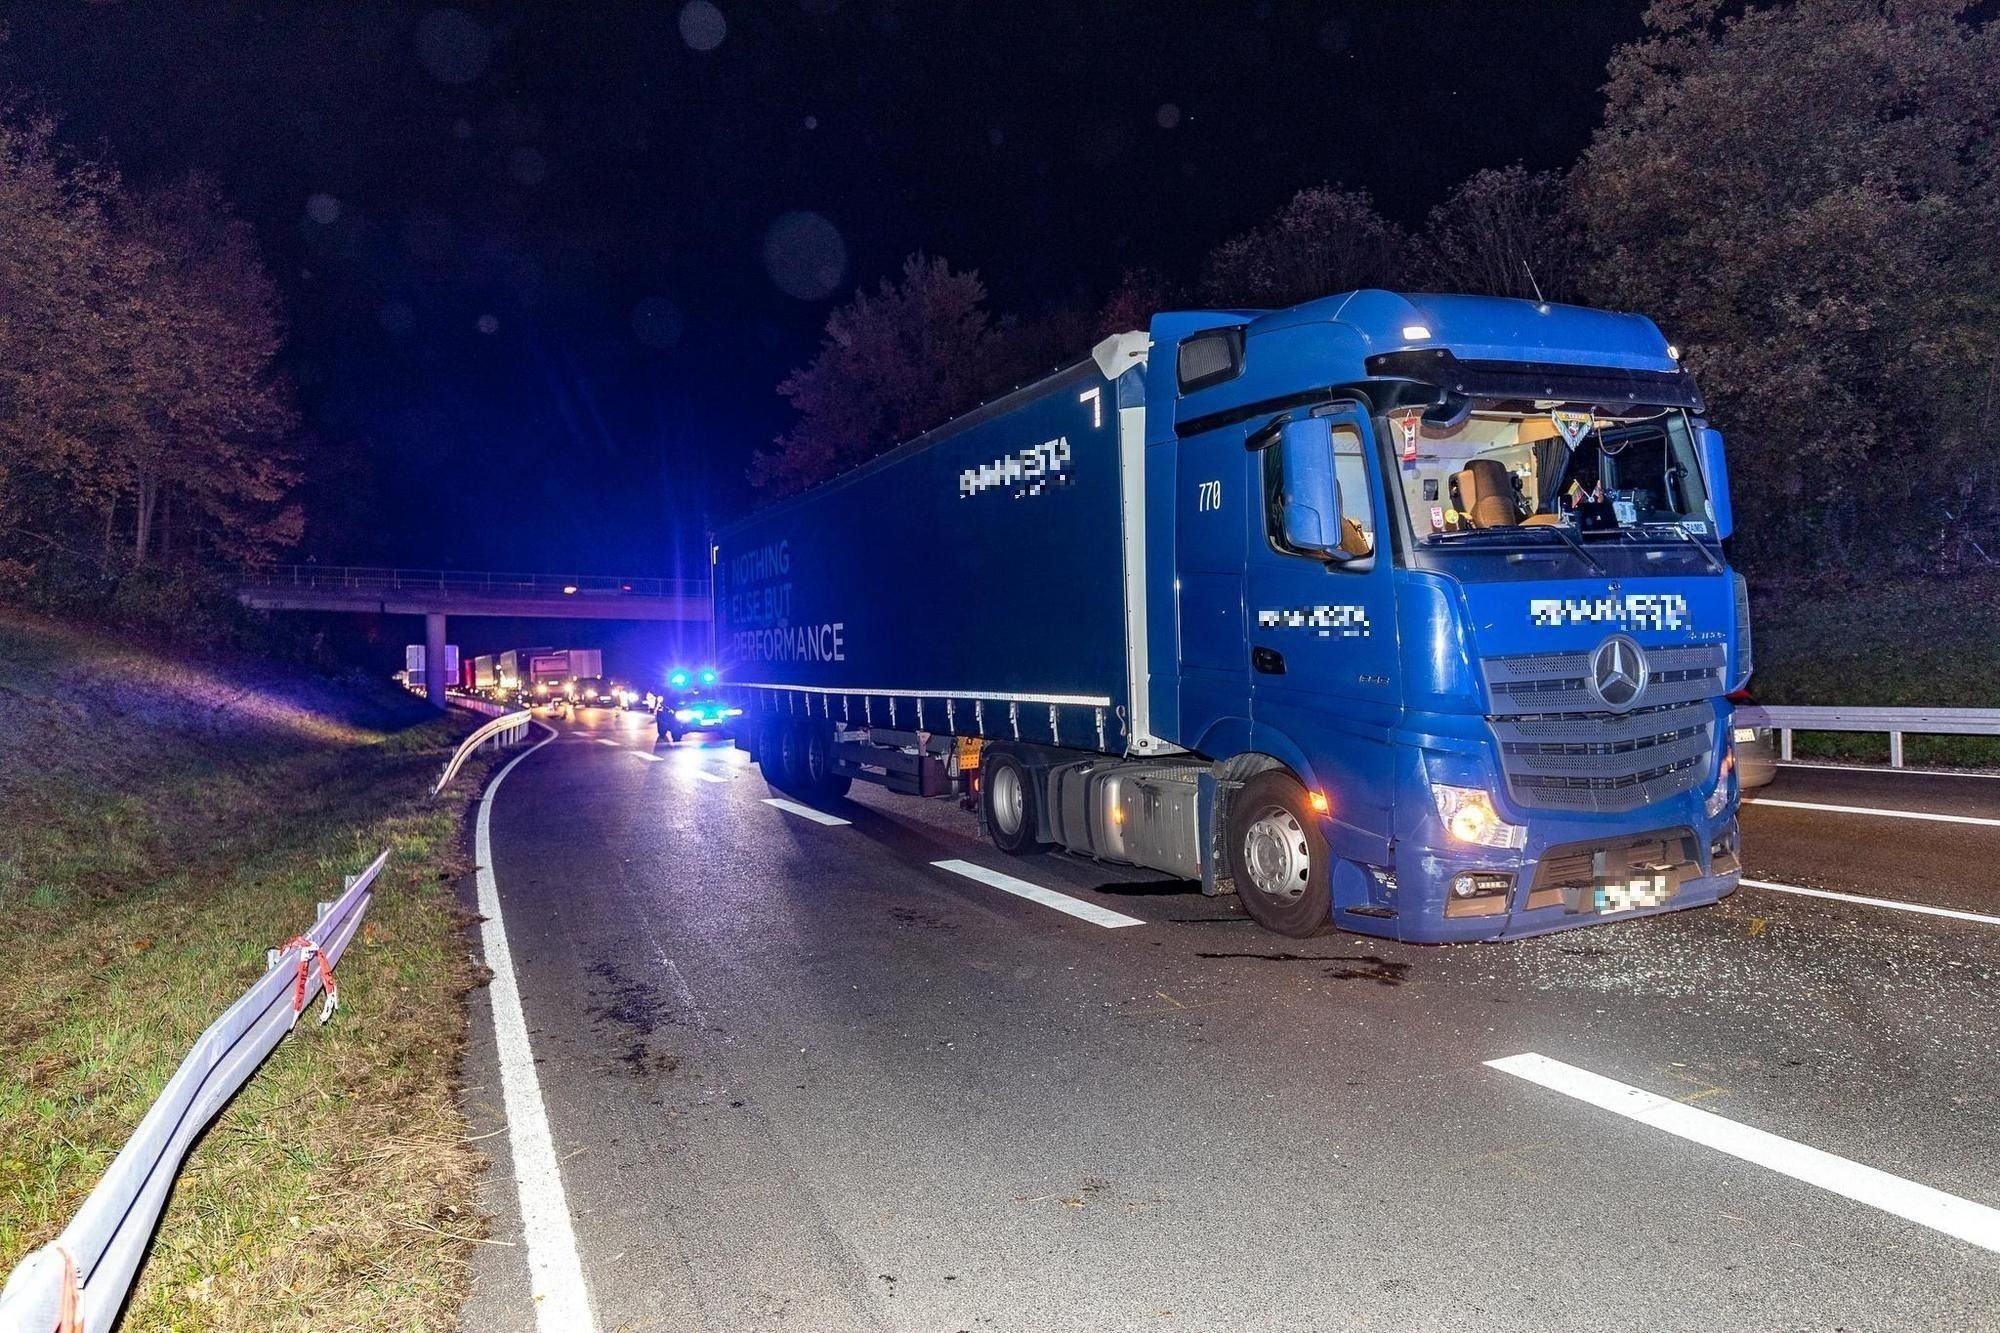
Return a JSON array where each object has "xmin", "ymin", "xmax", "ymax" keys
[{"xmin": 1484, "ymin": 644, "xmax": 1724, "ymax": 815}]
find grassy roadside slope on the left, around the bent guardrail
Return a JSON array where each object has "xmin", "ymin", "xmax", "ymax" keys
[{"xmin": 0, "ymin": 614, "xmax": 494, "ymax": 1331}]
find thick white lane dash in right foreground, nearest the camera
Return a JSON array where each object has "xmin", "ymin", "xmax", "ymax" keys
[{"xmin": 1486, "ymin": 1051, "xmax": 2000, "ymax": 1253}]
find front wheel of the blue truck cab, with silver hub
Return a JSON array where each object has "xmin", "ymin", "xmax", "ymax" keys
[{"xmin": 1228, "ymin": 769, "xmax": 1334, "ymax": 939}]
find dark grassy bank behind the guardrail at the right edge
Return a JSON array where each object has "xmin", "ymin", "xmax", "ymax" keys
[{"xmin": 1750, "ymin": 572, "xmax": 2000, "ymax": 769}]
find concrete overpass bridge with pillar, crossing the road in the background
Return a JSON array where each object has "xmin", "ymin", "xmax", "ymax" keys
[{"xmin": 236, "ymin": 564, "xmax": 708, "ymax": 709}]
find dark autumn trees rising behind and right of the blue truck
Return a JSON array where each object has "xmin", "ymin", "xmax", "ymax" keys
[{"xmin": 752, "ymin": 0, "xmax": 2000, "ymax": 572}]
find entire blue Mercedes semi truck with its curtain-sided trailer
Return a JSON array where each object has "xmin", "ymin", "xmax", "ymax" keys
[{"xmin": 712, "ymin": 290, "xmax": 1750, "ymax": 941}]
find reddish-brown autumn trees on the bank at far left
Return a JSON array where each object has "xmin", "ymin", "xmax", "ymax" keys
[{"xmin": 0, "ymin": 106, "xmax": 302, "ymax": 586}]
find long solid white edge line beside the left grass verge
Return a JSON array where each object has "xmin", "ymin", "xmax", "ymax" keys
[{"xmin": 472, "ymin": 741, "xmax": 598, "ymax": 1333}]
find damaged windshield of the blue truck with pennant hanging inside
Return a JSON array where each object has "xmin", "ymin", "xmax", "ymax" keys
[{"xmin": 1382, "ymin": 400, "xmax": 1710, "ymax": 546}]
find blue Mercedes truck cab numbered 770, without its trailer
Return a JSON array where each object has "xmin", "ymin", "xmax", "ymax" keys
[{"xmin": 1144, "ymin": 292, "xmax": 1750, "ymax": 941}]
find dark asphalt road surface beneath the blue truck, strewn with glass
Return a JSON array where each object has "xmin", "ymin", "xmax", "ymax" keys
[{"xmin": 464, "ymin": 713, "xmax": 2000, "ymax": 1333}]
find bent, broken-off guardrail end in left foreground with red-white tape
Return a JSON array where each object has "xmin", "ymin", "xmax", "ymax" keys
[{"xmin": 0, "ymin": 851, "xmax": 388, "ymax": 1333}]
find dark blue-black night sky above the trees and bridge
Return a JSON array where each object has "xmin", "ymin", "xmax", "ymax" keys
[{"xmin": 0, "ymin": 0, "xmax": 1642, "ymax": 574}]
